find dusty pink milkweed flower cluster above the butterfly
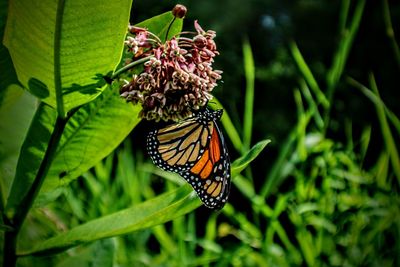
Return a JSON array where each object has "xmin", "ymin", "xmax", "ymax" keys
[{"xmin": 121, "ymin": 18, "xmax": 222, "ymax": 121}]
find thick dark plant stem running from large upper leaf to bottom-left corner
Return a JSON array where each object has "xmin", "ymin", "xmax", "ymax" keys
[{"xmin": 3, "ymin": 115, "xmax": 69, "ymax": 267}]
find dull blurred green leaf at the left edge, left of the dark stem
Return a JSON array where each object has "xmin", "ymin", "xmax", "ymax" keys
[{"xmin": 0, "ymin": 85, "xmax": 36, "ymax": 203}]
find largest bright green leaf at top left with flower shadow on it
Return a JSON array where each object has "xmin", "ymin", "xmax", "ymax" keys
[{"xmin": 4, "ymin": 0, "xmax": 131, "ymax": 116}]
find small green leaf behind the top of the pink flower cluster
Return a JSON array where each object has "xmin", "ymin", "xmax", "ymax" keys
[{"xmin": 135, "ymin": 11, "xmax": 183, "ymax": 41}]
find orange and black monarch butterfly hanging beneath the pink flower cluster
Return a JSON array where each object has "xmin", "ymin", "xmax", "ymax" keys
[{"xmin": 147, "ymin": 108, "xmax": 231, "ymax": 210}]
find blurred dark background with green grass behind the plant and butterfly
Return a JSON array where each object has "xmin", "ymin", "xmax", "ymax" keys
[{"xmin": 9, "ymin": 0, "xmax": 400, "ymax": 266}]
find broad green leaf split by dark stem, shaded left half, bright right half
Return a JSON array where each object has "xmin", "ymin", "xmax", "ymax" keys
[{"xmin": 7, "ymin": 87, "xmax": 139, "ymax": 216}]
